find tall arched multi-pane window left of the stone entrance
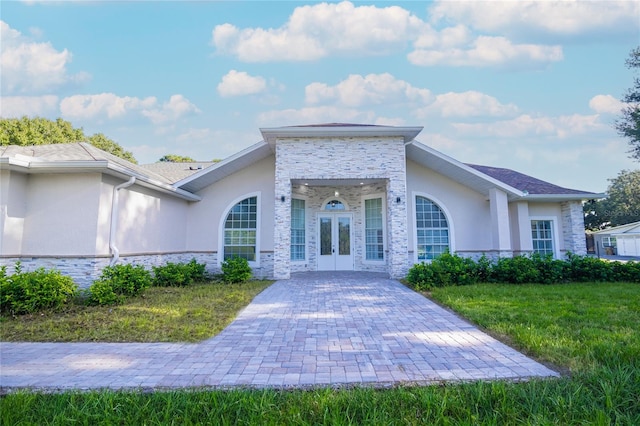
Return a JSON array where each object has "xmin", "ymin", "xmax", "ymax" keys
[{"xmin": 223, "ymin": 197, "xmax": 258, "ymax": 262}]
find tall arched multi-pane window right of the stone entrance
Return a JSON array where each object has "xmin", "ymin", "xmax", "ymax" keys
[{"xmin": 416, "ymin": 196, "xmax": 449, "ymax": 260}]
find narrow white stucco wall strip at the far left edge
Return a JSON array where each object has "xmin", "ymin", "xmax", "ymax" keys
[{"xmin": 0, "ymin": 170, "xmax": 27, "ymax": 256}]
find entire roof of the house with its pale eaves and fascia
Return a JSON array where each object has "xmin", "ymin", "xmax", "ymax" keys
[{"xmin": 0, "ymin": 123, "xmax": 604, "ymax": 201}]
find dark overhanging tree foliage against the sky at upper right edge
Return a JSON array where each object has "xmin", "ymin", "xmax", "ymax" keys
[{"xmin": 615, "ymin": 47, "xmax": 640, "ymax": 161}]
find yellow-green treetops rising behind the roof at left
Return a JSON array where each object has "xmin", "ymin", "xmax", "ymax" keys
[{"xmin": 0, "ymin": 116, "xmax": 137, "ymax": 164}]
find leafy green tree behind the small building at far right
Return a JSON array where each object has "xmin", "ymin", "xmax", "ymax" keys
[{"xmin": 584, "ymin": 170, "xmax": 640, "ymax": 231}]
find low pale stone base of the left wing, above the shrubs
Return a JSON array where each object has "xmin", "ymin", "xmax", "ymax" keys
[{"xmin": 0, "ymin": 252, "xmax": 273, "ymax": 288}]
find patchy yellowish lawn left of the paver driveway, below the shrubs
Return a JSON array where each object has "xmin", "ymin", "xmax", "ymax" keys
[{"xmin": 0, "ymin": 281, "xmax": 273, "ymax": 342}]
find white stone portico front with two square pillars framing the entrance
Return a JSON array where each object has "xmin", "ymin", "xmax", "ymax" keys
[{"xmin": 274, "ymin": 137, "xmax": 408, "ymax": 278}]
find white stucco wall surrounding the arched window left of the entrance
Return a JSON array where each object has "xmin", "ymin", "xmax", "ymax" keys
[{"xmin": 186, "ymin": 156, "xmax": 279, "ymax": 252}]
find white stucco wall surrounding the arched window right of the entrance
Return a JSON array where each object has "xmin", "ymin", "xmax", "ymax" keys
[{"xmin": 407, "ymin": 161, "xmax": 492, "ymax": 261}]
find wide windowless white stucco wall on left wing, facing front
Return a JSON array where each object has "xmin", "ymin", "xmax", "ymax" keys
[{"xmin": 20, "ymin": 173, "xmax": 101, "ymax": 256}]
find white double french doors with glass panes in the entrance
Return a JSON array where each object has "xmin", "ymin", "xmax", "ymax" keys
[{"xmin": 318, "ymin": 213, "xmax": 353, "ymax": 271}]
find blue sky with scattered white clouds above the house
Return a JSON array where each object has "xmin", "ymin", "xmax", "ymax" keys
[{"xmin": 0, "ymin": 0, "xmax": 640, "ymax": 192}]
